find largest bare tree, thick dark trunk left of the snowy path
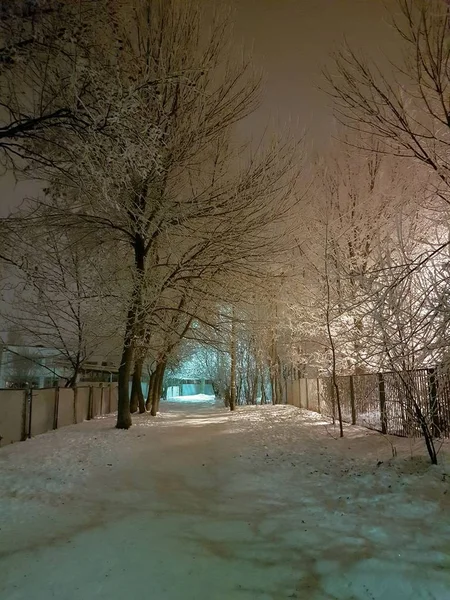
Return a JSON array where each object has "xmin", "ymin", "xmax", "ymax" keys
[{"xmin": 29, "ymin": 0, "xmax": 300, "ymax": 428}]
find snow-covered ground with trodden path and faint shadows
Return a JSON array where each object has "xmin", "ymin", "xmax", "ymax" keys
[{"xmin": 0, "ymin": 403, "xmax": 450, "ymax": 600}]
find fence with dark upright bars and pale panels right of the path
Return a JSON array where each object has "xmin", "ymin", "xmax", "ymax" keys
[{"xmin": 287, "ymin": 368, "xmax": 450, "ymax": 437}]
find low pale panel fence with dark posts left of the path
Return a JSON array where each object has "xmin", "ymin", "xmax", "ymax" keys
[{"xmin": 0, "ymin": 383, "xmax": 118, "ymax": 446}]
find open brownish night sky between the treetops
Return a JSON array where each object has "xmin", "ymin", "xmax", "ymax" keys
[{"xmin": 234, "ymin": 0, "xmax": 398, "ymax": 141}]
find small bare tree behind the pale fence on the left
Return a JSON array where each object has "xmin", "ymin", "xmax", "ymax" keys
[{"xmin": 3, "ymin": 227, "xmax": 120, "ymax": 387}]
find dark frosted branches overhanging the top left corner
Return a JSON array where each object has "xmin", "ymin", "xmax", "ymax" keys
[{"xmin": 0, "ymin": 0, "xmax": 111, "ymax": 171}]
